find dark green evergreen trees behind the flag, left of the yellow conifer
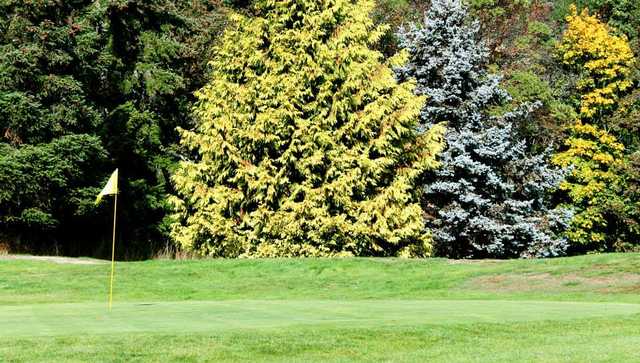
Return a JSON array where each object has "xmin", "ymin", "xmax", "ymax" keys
[{"xmin": 0, "ymin": 0, "xmax": 221, "ymax": 256}]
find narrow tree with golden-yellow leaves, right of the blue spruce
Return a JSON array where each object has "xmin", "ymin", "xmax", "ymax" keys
[{"xmin": 554, "ymin": 5, "xmax": 637, "ymax": 252}]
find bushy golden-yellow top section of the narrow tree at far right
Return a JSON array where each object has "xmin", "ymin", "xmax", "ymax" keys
[{"xmin": 558, "ymin": 5, "xmax": 634, "ymax": 119}]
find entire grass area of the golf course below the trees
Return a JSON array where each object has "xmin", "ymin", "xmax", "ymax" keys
[{"xmin": 0, "ymin": 254, "xmax": 640, "ymax": 362}]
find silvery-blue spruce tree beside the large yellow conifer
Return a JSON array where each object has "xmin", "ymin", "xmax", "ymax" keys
[{"xmin": 397, "ymin": 0, "xmax": 570, "ymax": 258}]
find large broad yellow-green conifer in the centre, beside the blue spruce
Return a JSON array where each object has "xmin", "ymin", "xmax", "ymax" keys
[{"xmin": 172, "ymin": 0, "xmax": 444, "ymax": 257}]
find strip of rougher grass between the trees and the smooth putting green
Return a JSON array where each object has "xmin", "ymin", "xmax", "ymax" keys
[{"xmin": 0, "ymin": 254, "xmax": 640, "ymax": 305}]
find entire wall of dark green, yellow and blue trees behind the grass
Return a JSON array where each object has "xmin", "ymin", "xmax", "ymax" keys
[{"xmin": 0, "ymin": 0, "xmax": 640, "ymax": 259}]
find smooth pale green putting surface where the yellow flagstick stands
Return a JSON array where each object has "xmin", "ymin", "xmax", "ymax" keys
[{"xmin": 5, "ymin": 300, "xmax": 640, "ymax": 337}]
